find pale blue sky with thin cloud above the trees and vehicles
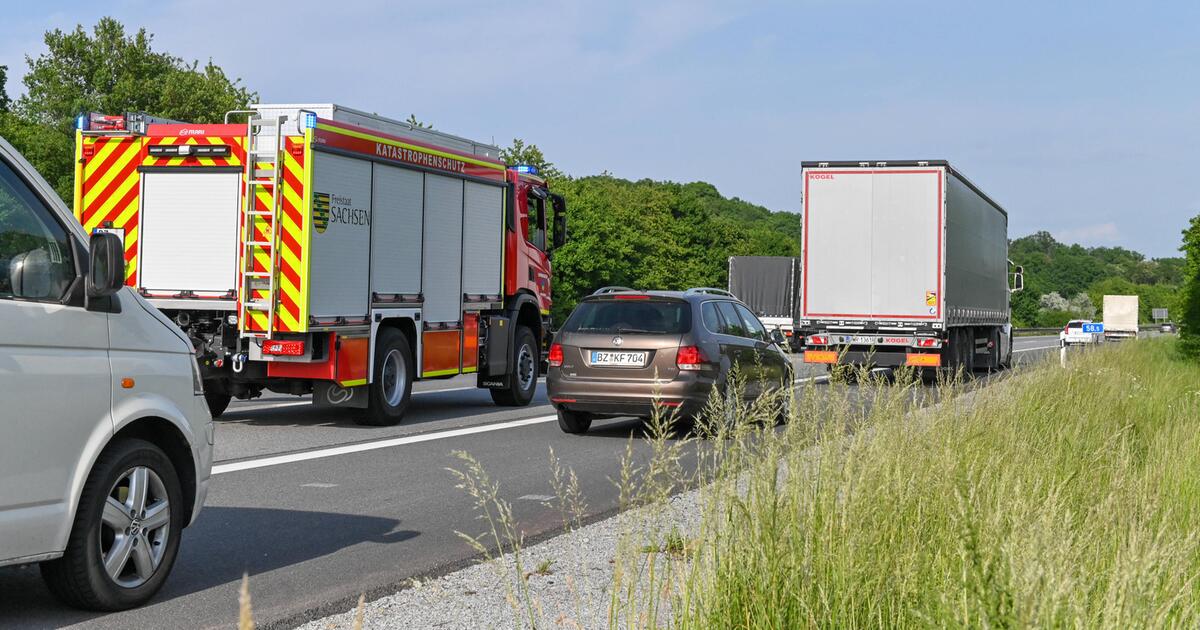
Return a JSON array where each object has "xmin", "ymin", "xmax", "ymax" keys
[{"xmin": 0, "ymin": 0, "xmax": 1200, "ymax": 257}]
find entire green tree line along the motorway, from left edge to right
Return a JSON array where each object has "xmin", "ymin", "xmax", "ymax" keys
[{"xmin": 0, "ymin": 18, "xmax": 1200, "ymax": 356}]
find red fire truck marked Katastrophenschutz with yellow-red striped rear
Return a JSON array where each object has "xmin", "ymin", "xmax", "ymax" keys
[{"xmin": 74, "ymin": 104, "xmax": 566, "ymax": 425}]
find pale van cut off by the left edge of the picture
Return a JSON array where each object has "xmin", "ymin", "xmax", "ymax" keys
[{"xmin": 0, "ymin": 138, "xmax": 214, "ymax": 611}]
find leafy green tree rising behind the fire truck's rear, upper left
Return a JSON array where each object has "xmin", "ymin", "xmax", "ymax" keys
[{"xmin": 0, "ymin": 18, "xmax": 258, "ymax": 200}]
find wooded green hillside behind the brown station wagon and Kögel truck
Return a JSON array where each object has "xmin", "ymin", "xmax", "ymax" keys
[{"xmin": 553, "ymin": 175, "xmax": 1184, "ymax": 326}]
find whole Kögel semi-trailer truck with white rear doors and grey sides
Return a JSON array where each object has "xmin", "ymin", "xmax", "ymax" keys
[{"xmin": 799, "ymin": 160, "xmax": 1022, "ymax": 371}]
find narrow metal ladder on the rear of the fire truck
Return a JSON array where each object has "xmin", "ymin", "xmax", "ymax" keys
[{"xmin": 238, "ymin": 115, "xmax": 287, "ymax": 340}]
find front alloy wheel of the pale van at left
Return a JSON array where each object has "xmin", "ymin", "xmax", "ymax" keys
[{"xmin": 41, "ymin": 439, "xmax": 184, "ymax": 611}]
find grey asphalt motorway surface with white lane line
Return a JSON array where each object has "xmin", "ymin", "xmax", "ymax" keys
[{"xmin": 0, "ymin": 337, "xmax": 1058, "ymax": 629}]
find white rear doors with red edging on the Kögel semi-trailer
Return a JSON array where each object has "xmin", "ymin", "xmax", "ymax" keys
[{"xmin": 802, "ymin": 167, "xmax": 944, "ymax": 320}]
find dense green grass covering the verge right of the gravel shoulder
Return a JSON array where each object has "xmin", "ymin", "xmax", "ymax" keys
[{"xmin": 686, "ymin": 340, "xmax": 1200, "ymax": 629}]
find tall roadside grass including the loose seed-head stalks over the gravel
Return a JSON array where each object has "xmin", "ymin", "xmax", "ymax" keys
[{"xmin": 448, "ymin": 340, "xmax": 1200, "ymax": 629}]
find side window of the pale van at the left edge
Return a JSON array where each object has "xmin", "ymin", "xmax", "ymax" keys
[{"xmin": 0, "ymin": 161, "xmax": 76, "ymax": 302}]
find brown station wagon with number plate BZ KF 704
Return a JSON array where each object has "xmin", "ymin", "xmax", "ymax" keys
[{"xmin": 546, "ymin": 287, "xmax": 793, "ymax": 433}]
